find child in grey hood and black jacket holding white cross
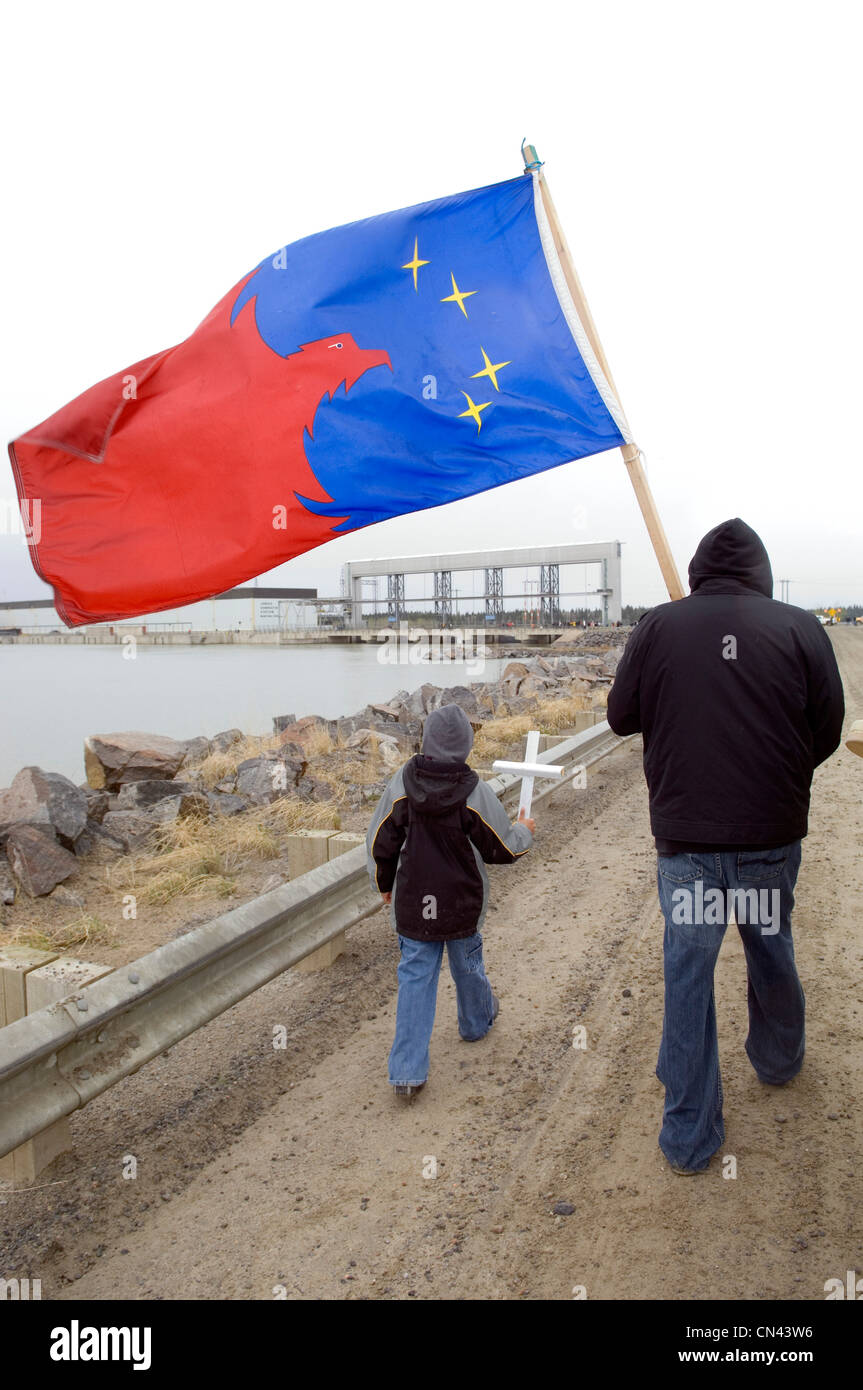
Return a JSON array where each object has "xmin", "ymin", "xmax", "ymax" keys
[{"xmin": 365, "ymin": 705, "xmax": 534, "ymax": 1097}]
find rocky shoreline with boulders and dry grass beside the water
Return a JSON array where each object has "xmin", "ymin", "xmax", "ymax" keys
[{"xmin": 0, "ymin": 628, "xmax": 628, "ymax": 927}]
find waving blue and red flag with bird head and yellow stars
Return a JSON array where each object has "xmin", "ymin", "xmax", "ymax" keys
[{"xmin": 10, "ymin": 174, "xmax": 631, "ymax": 627}]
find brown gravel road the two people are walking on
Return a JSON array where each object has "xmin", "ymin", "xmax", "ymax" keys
[{"xmin": 0, "ymin": 628, "xmax": 863, "ymax": 1300}]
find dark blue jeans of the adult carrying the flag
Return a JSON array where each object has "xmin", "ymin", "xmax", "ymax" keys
[{"xmin": 656, "ymin": 840, "xmax": 803, "ymax": 1169}]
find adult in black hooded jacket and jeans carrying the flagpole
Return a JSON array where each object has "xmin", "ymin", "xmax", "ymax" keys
[{"xmin": 609, "ymin": 517, "xmax": 845, "ymax": 1173}]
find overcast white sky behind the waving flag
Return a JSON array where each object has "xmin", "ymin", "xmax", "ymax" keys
[{"xmin": 0, "ymin": 0, "xmax": 863, "ymax": 606}]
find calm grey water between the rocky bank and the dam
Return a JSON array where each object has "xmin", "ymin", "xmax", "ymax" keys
[{"xmin": 0, "ymin": 644, "xmax": 506, "ymax": 787}]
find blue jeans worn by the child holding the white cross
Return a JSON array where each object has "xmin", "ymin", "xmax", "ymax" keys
[{"xmin": 389, "ymin": 931, "xmax": 493, "ymax": 1086}]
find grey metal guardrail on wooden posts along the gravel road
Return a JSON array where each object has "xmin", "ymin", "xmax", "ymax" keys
[{"xmin": 0, "ymin": 721, "xmax": 625, "ymax": 1156}]
